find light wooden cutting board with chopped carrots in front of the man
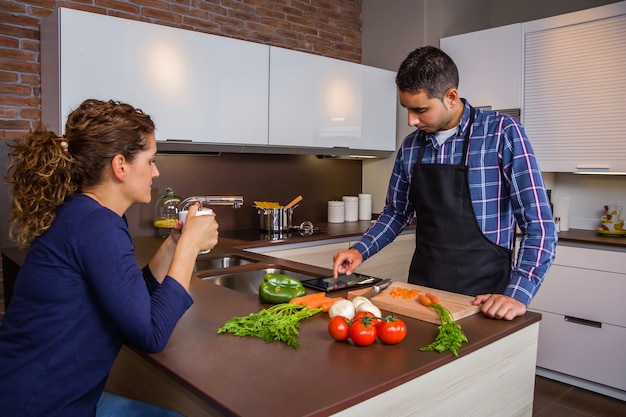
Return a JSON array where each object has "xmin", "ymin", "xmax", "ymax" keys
[{"xmin": 348, "ymin": 282, "xmax": 480, "ymax": 324}]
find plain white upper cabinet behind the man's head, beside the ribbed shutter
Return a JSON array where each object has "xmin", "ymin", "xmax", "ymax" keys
[{"xmin": 440, "ymin": 23, "xmax": 523, "ymax": 110}]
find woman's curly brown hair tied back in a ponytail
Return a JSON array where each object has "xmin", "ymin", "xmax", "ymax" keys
[{"xmin": 6, "ymin": 99, "xmax": 154, "ymax": 249}]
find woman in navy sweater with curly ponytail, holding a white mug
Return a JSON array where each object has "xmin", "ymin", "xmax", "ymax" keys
[{"xmin": 0, "ymin": 100, "xmax": 218, "ymax": 417}]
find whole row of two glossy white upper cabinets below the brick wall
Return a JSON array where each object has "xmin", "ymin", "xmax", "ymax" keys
[{"xmin": 41, "ymin": 8, "xmax": 397, "ymax": 156}]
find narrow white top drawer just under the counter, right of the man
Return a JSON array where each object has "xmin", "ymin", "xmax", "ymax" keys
[{"xmin": 554, "ymin": 245, "xmax": 626, "ymax": 275}]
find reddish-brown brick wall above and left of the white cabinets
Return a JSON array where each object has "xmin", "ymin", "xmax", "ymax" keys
[{"xmin": 0, "ymin": 0, "xmax": 361, "ymax": 140}]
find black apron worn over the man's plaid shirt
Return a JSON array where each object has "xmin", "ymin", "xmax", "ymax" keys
[{"xmin": 409, "ymin": 107, "xmax": 512, "ymax": 296}]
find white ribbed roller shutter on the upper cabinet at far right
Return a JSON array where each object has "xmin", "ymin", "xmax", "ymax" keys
[{"xmin": 522, "ymin": 15, "xmax": 626, "ymax": 166}]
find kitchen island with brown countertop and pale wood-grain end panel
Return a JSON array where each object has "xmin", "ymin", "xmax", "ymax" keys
[{"xmin": 101, "ymin": 238, "xmax": 541, "ymax": 417}]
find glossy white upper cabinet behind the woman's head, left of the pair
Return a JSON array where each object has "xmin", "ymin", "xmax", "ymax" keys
[{"xmin": 42, "ymin": 8, "xmax": 269, "ymax": 145}]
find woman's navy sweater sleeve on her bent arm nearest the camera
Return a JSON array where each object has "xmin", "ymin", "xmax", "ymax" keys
[{"xmin": 74, "ymin": 209, "xmax": 193, "ymax": 352}]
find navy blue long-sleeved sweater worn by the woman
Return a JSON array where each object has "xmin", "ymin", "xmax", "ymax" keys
[{"xmin": 0, "ymin": 194, "xmax": 193, "ymax": 417}]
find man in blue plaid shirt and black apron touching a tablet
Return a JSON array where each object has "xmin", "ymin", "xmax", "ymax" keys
[{"xmin": 333, "ymin": 46, "xmax": 557, "ymax": 320}]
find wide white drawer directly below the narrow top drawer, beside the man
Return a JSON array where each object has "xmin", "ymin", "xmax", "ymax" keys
[{"xmin": 530, "ymin": 264, "xmax": 626, "ymax": 327}]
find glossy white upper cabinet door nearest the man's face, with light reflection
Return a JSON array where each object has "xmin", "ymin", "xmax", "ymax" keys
[{"xmin": 269, "ymin": 47, "xmax": 397, "ymax": 152}]
